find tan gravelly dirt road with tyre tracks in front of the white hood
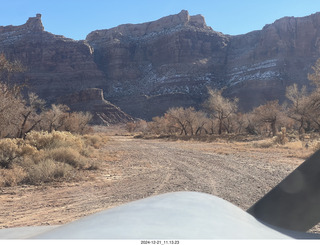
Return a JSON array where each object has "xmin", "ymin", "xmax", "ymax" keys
[{"xmin": 0, "ymin": 136, "xmax": 303, "ymax": 228}]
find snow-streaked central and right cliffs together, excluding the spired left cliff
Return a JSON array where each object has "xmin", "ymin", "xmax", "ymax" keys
[{"xmin": 87, "ymin": 11, "xmax": 320, "ymax": 116}]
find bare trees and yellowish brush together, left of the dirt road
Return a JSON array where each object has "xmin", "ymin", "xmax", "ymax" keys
[{"xmin": 0, "ymin": 54, "xmax": 102, "ymax": 186}]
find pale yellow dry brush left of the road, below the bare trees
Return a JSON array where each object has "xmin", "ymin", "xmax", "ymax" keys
[{"xmin": 0, "ymin": 131, "xmax": 108, "ymax": 187}]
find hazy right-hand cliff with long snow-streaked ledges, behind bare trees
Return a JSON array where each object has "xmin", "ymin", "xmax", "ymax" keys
[{"xmin": 225, "ymin": 13, "xmax": 320, "ymax": 109}]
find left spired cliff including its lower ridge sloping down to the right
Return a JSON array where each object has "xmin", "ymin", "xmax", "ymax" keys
[{"xmin": 0, "ymin": 14, "xmax": 133, "ymax": 125}]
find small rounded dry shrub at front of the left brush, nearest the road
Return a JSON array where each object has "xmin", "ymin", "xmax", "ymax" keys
[{"xmin": 24, "ymin": 159, "xmax": 73, "ymax": 184}]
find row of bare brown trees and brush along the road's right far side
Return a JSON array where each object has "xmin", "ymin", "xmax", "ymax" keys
[{"xmin": 128, "ymin": 59, "xmax": 320, "ymax": 149}]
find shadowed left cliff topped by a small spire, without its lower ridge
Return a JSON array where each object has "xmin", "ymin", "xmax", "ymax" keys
[{"xmin": 0, "ymin": 14, "xmax": 105, "ymax": 103}]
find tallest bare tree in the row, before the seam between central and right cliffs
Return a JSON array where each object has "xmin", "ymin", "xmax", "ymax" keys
[{"xmin": 203, "ymin": 88, "xmax": 239, "ymax": 134}]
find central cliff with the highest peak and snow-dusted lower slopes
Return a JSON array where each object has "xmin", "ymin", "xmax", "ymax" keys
[{"xmin": 87, "ymin": 11, "xmax": 229, "ymax": 119}]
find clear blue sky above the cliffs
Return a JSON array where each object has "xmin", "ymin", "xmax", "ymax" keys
[{"xmin": 0, "ymin": 0, "xmax": 320, "ymax": 40}]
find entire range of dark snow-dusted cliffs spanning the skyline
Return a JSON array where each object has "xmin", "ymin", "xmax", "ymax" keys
[{"xmin": 0, "ymin": 10, "xmax": 320, "ymax": 119}]
